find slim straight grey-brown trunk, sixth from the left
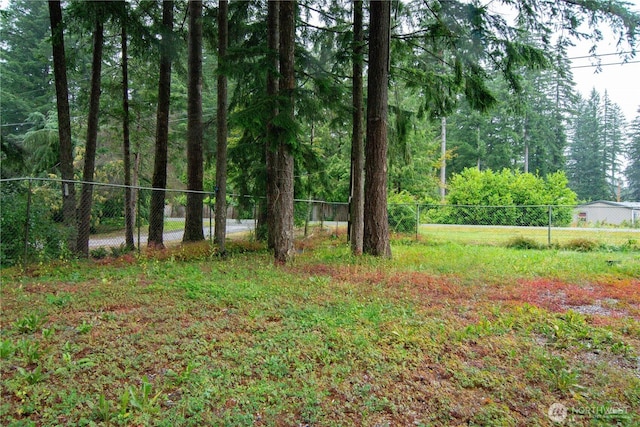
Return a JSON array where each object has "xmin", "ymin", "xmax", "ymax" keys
[{"xmin": 214, "ymin": 0, "xmax": 229, "ymax": 253}]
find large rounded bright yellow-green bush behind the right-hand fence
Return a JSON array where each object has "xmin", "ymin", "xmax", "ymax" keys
[{"xmin": 440, "ymin": 168, "xmax": 576, "ymax": 226}]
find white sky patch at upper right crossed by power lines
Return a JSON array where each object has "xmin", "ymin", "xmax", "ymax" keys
[{"xmin": 568, "ymin": 0, "xmax": 640, "ymax": 122}]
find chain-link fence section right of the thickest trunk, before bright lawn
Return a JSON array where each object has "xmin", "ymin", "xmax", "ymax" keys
[{"xmin": 388, "ymin": 202, "xmax": 640, "ymax": 249}]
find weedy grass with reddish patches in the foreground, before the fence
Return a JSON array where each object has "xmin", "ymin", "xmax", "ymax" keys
[{"xmin": 0, "ymin": 233, "xmax": 640, "ymax": 426}]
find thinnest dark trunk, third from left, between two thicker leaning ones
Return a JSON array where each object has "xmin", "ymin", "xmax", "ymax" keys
[{"xmin": 120, "ymin": 8, "xmax": 135, "ymax": 249}]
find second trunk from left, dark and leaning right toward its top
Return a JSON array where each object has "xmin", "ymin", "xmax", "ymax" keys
[{"xmin": 77, "ymin": 16, "xmax": 104, "ymax": 256}]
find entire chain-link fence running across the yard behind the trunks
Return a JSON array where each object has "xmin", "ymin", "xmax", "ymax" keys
[{"xmin": 0, "ymin": 178, "xmax": 640, "ymax": 265}]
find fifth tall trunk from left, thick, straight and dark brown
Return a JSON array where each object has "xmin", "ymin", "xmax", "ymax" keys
[{"xmin": 183, "ymin": 0, "xmax": 204, "ymax": 242}]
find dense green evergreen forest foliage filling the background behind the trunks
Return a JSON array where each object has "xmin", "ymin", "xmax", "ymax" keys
[{"xmin": 0, "ymin": 0, "xmax": 640, "ymax": 258}]
